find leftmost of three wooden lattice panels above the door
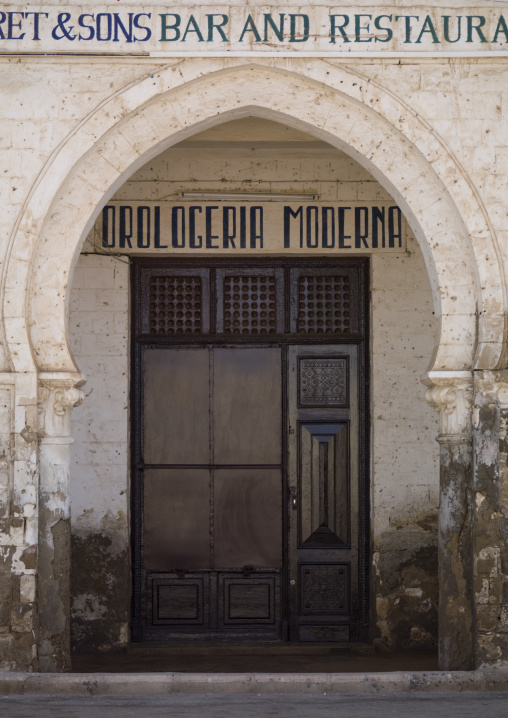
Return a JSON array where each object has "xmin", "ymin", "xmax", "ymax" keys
[{"xmin": 150, "ymin": 276, "xmax": 202, "ymax": 334}]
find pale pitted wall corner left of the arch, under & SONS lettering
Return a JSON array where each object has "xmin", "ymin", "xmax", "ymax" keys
[{"xmin": 0, "ymin": 57, "xmax": 162, "ymax": 380}]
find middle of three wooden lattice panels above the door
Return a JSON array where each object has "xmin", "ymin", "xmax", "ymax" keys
[{"xmin": 224, "ymin": 276, "xmax": 276, "ymax": 334}]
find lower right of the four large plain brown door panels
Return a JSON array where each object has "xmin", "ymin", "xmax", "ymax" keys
[{"xmin": 214, "ymin": 469, "xmax": 282, "ymax": 569}]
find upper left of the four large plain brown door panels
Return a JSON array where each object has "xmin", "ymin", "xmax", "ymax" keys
[{"xmin": 143, "ymin": 348, "xmax": 210, "ymax": 464}]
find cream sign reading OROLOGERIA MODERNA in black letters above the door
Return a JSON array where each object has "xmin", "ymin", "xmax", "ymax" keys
[{"xmin": 94, "ymin": 201, "xmax": 407, "ymax": 255}]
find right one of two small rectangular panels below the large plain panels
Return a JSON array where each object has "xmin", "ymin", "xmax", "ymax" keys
[{"xmin": 219, "ymin": 574, "xmax": 279, "ymax": 626}]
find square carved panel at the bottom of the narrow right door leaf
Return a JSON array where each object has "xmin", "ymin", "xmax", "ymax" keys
[{"xmin": 300, "ymin": 563, "xmax": 349, "ymax": 616}]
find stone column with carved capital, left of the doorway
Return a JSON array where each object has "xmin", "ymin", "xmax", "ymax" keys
[{"xmin": 38, "ymin": 372, "xmax": 84, "ymax": 672}]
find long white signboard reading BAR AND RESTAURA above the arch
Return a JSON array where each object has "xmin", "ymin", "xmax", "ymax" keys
[{"xmin": 0, "ymin": 2, "xmax": 508, "ymax": 56}]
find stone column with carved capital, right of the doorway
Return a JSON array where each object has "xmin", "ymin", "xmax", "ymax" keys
[{"xmin": 424, "ymin": 371, "xmax": 474, "ymax": 670}]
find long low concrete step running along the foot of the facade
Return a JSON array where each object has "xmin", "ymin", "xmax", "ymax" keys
[{"xmin": 0, "ymin": 670, "xmax": 508, "ymax": 696}]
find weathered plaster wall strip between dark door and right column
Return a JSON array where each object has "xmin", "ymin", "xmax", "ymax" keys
[{"xmin": 372, "ymin": 246, "xmax": 439, "ymax": 649}]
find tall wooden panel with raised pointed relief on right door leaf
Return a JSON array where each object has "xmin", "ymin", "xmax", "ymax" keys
[{"xmin": 299, "ymin": 422, "xmax": 350, "ymax": 548}]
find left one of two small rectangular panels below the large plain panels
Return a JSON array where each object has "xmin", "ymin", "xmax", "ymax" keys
[{"xmin": 152, "ymin": 576, "xmax": 208, "ymax": 626}]
